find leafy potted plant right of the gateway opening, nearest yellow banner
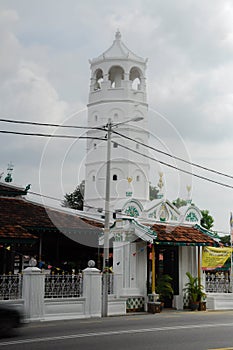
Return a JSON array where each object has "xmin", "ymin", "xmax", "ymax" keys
[{"xmin": 183, "ymin": 272, "xmax": 205, "ymax": 310}]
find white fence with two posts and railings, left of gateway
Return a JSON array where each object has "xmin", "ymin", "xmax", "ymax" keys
[{"xmin": 0, "ymin": 267, "xmax": 126, "ymax": 320}]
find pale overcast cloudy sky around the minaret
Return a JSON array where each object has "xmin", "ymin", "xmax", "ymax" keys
[{"xmin": 0, "ymin": 0, "xmax": 233, "ymax": 233}]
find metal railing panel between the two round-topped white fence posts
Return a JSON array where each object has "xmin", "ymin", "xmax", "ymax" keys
[{"xmin": 44, "ymin": 274, "xmax": 83, "ymax": 298}]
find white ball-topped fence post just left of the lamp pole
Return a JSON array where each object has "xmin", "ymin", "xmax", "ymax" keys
[{"xmin": 83, "ymin": 260, "xmax": 102, "ymax": 317}]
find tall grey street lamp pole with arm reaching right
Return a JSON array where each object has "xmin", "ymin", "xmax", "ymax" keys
[{"xmin": 102, "ymin": 117, "xmax": 144, "ymax": 317}]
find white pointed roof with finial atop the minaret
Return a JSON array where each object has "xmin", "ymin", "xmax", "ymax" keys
[{"xmin": 90, "ymin": 29, "xmax": 147, "ymax": 63}]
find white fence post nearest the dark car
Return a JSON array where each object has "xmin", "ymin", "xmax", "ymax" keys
[{"xmin": 22, "ymin": 263, "xmax": 45, "ymax": 321}]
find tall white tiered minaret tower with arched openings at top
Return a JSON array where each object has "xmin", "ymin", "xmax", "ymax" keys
[{"xmin": 84, "ymin": 31, "xmax": 149, "ymax": 215}]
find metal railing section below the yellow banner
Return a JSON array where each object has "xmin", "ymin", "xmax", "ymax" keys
[{"xmin": 205, "ymin": 272, "xmax": 231, "ymax": 293}]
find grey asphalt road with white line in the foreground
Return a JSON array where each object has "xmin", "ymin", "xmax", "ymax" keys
[{"xmin": 0, "ymin": 311, "xmax": 233, "ymax": 350}]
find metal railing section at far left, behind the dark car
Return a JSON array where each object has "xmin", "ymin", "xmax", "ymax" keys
[{"xmin": 0, "ymin": 275, "xmax": 22, "ymax": 300}]
